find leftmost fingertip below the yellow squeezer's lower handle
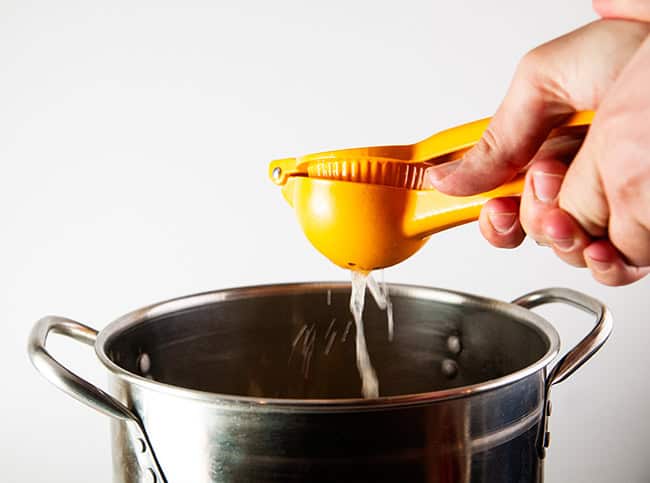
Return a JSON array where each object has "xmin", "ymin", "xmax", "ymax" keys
[{"xmin": 479, "ymin": 197, "xmax": 526, "ymax": 248}]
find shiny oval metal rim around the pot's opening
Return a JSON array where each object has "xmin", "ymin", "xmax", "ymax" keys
[{"xmin": 95, "ymin": 282, "xmax": 560, "ymax": 411}]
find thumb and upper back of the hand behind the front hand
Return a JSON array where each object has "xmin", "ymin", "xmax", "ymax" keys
[{"xmin": 426, "ymin": 20, "xmax": 650, "ymax": 196}]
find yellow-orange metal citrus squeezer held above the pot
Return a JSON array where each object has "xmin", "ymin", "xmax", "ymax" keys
[{"xmin": 269, "ymin": 111, "xmax": 594, "ymax": 271}]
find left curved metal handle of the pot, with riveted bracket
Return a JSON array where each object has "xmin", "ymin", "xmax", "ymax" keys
[{"xmin": 27, "ymin": 316, "xmax": 167, "ymax": 482}]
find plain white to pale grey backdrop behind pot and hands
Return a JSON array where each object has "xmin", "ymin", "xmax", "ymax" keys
[{"xmin": 0, "ymin": 0, "xmax": 650, "ymax": 483}]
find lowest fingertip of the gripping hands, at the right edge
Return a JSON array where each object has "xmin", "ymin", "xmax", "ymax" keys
[{"xmin": 584, "ymin": 240, "xmax": 650, "ymax": 286}]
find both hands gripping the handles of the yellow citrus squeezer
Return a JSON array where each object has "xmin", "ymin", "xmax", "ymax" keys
[{"xmin": 428, "ymin": 17, "xmax": 650, "ymax": 285}]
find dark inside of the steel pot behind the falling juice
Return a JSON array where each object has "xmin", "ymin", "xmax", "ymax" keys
[{"xmin": 105, "ymin": 283, "xmax": 552, "ymax": 399}]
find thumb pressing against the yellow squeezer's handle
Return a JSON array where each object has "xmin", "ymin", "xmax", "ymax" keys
[{"xmin": 425, "ymin": 50, "xmax": 574, "ymax": 196}]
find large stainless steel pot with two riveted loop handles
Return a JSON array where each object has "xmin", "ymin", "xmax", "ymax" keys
[{"xmin": 29, "ymin": 283, "xmax": 611, "ymax": 483}]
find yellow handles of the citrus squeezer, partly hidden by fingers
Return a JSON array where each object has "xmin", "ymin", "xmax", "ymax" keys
[{"xmin": 404, "ymin": 111, "xmax": 594, "ymax": 238}]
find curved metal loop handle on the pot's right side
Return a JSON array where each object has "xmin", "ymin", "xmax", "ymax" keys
[{"xmin": 512, "ymin": 288, "xmax": 612, "ymax": 387}]
